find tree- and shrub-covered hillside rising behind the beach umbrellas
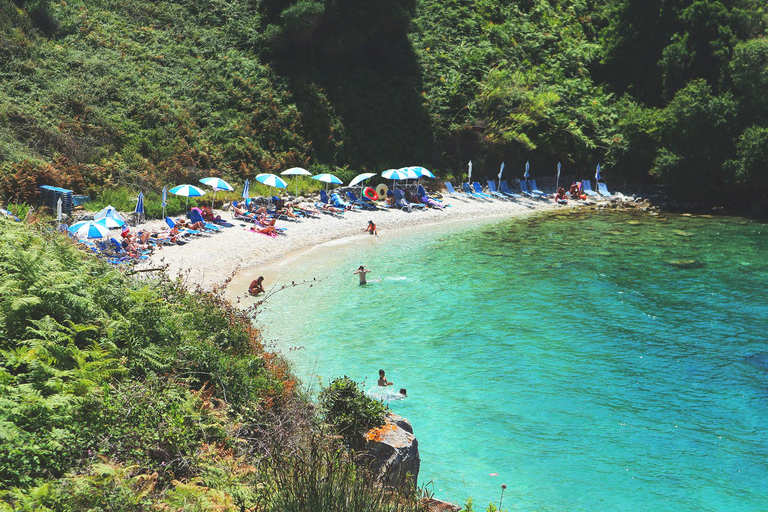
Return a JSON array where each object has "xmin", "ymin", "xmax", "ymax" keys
[{"xmin": 0, "ymin": 0, "xmax": 768, "ymax": 206}]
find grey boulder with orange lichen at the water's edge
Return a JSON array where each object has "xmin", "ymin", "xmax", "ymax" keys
[{"xmin": 365, "ymin": 414, "xmax": 421, "ymax": 491}]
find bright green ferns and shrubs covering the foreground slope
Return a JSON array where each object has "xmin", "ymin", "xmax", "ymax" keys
[{"xmin": 0, "ymin": 217, "xmax": 432, "ymax": 512}]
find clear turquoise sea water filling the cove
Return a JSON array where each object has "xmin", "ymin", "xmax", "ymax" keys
[{"xmin": 261, "ymin": 212, "xmax": 768, "ymax": 511}]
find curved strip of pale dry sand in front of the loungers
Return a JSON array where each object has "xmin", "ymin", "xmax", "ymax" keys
[{"xmin": 135, "ymin": 190, "xmax": 576, "ymax": 298}]
